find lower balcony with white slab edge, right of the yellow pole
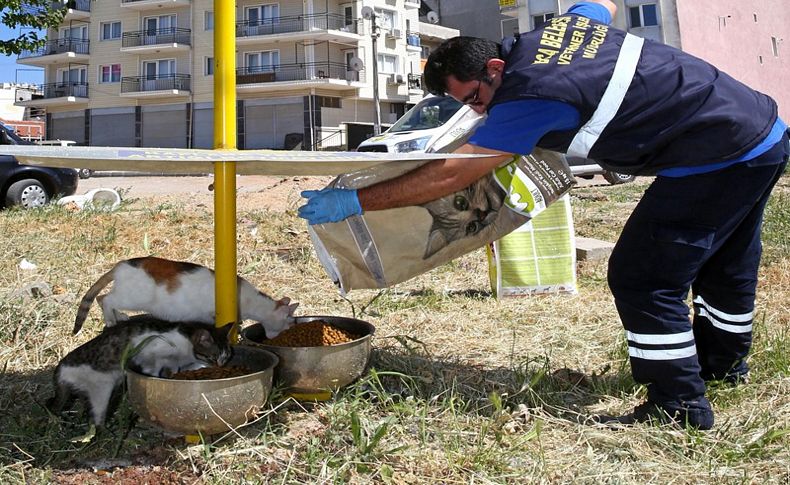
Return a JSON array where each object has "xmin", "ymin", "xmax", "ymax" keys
[{"xmin": 236, "ymin": 62, "xmax": 365, "ymax": 93}]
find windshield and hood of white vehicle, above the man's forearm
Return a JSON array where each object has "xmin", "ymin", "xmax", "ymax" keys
[{"xmin": 357, "ymin": 94, "xmax": 480, "ymax": 153}]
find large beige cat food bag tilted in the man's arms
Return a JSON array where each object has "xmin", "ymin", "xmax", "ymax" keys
[{"xmin": 309, "ymin": 116, "xmax": 574, "ymax": 294}]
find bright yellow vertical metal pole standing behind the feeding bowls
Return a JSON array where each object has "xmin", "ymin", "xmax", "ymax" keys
[{"xmin": 214, "ymin": 0, "xmax": 238, "ymax": 342}]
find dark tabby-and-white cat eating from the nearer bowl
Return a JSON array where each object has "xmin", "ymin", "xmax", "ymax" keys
[{"xmin": 47, "ymin": 316, "xmax": 233, "ymax": 427}]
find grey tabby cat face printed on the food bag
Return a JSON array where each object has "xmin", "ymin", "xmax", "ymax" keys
[{"xmin": 422, "ymin": 177, "xmax": 504, "ymax": 259}]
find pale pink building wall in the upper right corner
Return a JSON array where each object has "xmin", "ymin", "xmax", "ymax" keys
[{"xmin": 677, "ymin": 0, "xmax": 790, "ymax": 121}]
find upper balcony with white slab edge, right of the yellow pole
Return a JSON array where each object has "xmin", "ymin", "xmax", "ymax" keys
[{"xmin": 236, "ymin": 13, "xmax": 362, "ymax": 45}]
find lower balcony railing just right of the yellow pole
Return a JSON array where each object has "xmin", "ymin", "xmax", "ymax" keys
[{"xmin": 236, "ymin": 62, "xmax": 364, "ymax": 84}]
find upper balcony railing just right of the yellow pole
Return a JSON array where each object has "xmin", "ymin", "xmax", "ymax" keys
[{"xmin": 236, "ymin": 13, "xmax": 361, "ymax": 37}]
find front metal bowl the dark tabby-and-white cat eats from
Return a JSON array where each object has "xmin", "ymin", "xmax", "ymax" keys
[{"xmin": 126, "ymin": 345, "xmax": 278, "ymax": 435}]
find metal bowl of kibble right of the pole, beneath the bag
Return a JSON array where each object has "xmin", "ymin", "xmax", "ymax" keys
[{"xmin": 241, "ymin": 316, "xmax": 376, "ymax": 393}]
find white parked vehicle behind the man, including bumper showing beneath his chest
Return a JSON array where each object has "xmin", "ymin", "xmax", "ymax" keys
[{"xmin": 357, "ymin": 95, "xmax": 636, "ymax": 184}]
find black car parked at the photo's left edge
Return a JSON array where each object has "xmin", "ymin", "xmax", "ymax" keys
[{"xmin": 0, "ymin": 123, "xmax": 78, "ymax": 209}]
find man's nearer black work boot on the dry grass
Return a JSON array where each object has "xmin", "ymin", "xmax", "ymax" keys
[{"xmin": 592, "ymin": 397, "xmax": 713, "ymax": 430}]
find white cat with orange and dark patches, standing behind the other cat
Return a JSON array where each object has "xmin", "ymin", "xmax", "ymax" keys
[{"xmin": 73, "ymin": 256, "xmax": 299, "ymax": 338}]
